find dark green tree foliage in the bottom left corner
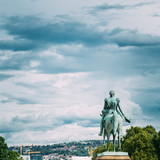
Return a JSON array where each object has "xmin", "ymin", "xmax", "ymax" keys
[{"xmin": 0, "ymin": 137, "xmax": 21, "ymax": 160}]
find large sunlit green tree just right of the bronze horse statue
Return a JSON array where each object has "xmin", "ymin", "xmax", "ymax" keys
[{"xmin": 122, "ymin": 126, "xmax": 158, "ymax": 160}]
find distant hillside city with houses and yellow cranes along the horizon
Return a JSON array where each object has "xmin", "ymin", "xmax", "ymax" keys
[{"xmin": 9, "ymin": 140, "xmax": 102, "ymax": 160}]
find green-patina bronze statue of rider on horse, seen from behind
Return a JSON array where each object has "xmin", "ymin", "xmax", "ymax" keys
[{"xmin": 99, "ymin": 90, "xmax": 131, "ymax": 152}]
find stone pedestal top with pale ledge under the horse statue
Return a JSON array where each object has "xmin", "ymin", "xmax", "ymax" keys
[{"xmin": 96, "ymin": 152, "xmax": 131, "ymax": 160}]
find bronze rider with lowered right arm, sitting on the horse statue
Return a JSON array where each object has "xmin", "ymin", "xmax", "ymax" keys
[{"xmin": 99, "ymin": 90, "xmax": 131, "ymax": 136}]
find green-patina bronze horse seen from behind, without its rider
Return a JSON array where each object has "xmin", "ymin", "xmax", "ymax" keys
[{"xmin": 103, "ymin": 112, "xmax": 123, "ymax": 152}]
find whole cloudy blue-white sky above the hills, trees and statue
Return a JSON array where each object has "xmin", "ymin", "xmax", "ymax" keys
[{"xmin": 0, "ymin": 0, "xmax": 160, "ymax": 146}]
